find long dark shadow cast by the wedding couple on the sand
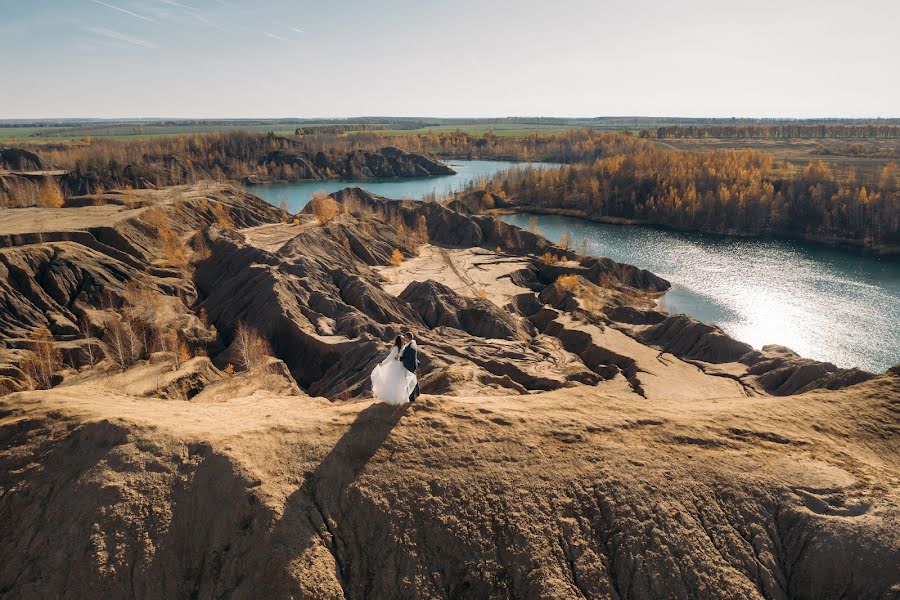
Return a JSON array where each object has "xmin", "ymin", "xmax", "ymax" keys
[{"xmin": 270, "ymin": 403, "xmax": 408, "ymax": 596}]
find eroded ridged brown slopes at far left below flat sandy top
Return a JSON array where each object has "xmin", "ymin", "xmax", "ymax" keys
[{"xmin": 0, "ymin": 186, "xmax": 280, "ymax": 389}]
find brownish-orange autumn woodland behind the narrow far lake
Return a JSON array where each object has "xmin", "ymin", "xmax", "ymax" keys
[{"xmin": 0, "ymin": 130, "xmax": 650, "ymax": 198}]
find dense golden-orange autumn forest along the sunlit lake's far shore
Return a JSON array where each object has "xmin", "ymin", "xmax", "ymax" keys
[{"xmin": 476, "ymin": 149, "xmax": 900, "ymax": 249}]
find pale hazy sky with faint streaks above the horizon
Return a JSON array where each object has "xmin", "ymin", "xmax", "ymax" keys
[{"xmin": 0, "ymin": 0, "xmax": 900, "ymax": 119}]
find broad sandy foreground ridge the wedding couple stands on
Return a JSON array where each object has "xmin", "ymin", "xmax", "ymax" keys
[{"xmin": 0, "ymin": 378, "xmax": 900, "ymax": 600}]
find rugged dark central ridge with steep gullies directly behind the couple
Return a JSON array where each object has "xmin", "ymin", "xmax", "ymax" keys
[{"xmin": 195, "ymin": 195, "xmax": 596, "ymax": 397}]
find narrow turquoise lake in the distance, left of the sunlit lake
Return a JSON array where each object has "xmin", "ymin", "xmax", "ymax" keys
[{"xmin": 246, "ymin": 160, "xmax": 559, "ymax": 213}]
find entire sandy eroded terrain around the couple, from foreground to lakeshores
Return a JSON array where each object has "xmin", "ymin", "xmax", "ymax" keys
[{"xmin": 0, "ymin": 186, "xmax": 900, "ymax": 598}]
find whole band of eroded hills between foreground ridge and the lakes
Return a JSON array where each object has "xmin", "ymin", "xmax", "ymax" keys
[{"xmin": 0, "ymin": 186, "xmax": 868, "ymax": 398}]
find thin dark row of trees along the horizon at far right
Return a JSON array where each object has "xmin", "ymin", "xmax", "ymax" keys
[{"xmin": 639, "ymin": 124, "xmax": 900, "ymax": 139}]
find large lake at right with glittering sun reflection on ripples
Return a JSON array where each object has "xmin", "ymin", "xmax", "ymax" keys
[{"xmin": 503, "ymin": 215, "xmax": 900, "ymax": 371}]
